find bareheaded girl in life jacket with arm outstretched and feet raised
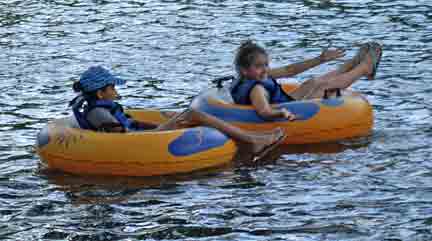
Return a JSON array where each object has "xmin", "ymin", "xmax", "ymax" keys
[{"xmin": 231, "ymin": 40, "xmax": 382, "ymax": 120}]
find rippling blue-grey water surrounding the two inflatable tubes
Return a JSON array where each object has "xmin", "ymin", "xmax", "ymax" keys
[{"xmin": 0, "ymin": 0, "xmax": 432, "ymax": 241}]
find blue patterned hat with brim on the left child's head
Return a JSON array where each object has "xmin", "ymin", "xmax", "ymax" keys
[{"xmin": 79, "ymin": 66, "xmax": 126, "ymax": 92}]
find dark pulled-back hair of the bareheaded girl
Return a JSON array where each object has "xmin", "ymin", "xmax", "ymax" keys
[{"xmin": 234, "ymin": 40, "xmax": 267, "ymax": 78}]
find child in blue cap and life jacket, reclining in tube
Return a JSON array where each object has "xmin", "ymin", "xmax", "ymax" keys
[{"xmin": 70, "ymin": 66, "xmax": 285, "ymax": 160}]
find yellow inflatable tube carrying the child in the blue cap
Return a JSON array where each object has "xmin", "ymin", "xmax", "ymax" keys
[{"xmin": 36, "ymin": 110, "xmax": 237, "ymax": 176}]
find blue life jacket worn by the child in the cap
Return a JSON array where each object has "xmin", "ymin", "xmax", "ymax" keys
[{"xmin": 72, "ymin": 98, "xmax": 134, "ymax": 130}]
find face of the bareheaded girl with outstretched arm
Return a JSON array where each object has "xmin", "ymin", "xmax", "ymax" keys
[{"xmin": 241, "ymin": 53, "xmax": 269, "ymax": 81}]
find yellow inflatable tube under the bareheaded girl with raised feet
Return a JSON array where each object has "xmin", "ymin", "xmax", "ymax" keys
[{"xmin": 192, "ymin": 84, "xmax": 373, "ymax": 144}]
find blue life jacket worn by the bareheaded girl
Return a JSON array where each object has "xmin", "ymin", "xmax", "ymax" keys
[{"xmin": 230, "ymin": 78, "xmax": 294, "ymax": 105}]
